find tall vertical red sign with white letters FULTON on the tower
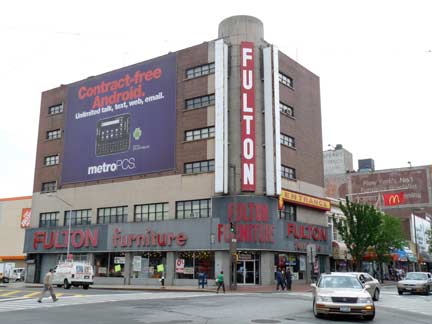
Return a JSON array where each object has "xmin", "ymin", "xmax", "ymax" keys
[{"xmin": 240, "ymin": 42, "xmax": 255, "ymax": 191}]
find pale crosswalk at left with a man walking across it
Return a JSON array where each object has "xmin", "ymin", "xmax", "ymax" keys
[{"xmin": 0, "ymin": 292, "xmax": 215, "ymax": 313}]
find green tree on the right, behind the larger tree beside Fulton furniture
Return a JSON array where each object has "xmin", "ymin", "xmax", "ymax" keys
[{"xmin": 374, "ymin": 213, "xmax": 405, "ymax": 282}]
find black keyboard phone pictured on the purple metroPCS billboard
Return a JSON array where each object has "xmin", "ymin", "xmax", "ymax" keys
[{"xmin": 96, "ymin": 114, "xmax": 130, "ymax": 156}]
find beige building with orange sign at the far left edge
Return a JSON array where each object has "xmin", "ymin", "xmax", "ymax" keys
[{"xmin": 0, "ymin": 196, "xmax": 32, "ymax": 268}]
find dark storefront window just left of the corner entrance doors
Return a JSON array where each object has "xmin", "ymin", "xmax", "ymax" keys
[{"xmin": 176, "ymin": 251, "xmax": 214, "ymax": 279}]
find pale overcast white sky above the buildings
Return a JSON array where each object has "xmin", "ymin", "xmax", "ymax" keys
[{"xmin": 0, "ymin": 0, "xmax": 432, "ymax": 198}]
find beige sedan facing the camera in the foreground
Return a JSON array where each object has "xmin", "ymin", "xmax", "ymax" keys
[{"xmin": 311, "ymin": 272, "xmax": 375, "ymax": 321}]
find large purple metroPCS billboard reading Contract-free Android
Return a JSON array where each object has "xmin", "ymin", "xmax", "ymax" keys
[{"xmin": 62, "ymin": 54, "xmax": 176, "ymax": 184}]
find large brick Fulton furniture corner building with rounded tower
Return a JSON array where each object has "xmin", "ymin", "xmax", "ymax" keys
[{"xmin": 25, "ymin": 16, "xmax": 331, "ymax": 285}]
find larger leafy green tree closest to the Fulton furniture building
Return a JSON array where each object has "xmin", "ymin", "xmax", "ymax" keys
[{"xmin": 335, "ymin": 199, "xmax": 381, "ymax": 271}]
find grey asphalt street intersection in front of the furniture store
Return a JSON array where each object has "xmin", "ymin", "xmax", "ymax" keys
[{"xmin": 0, "ymin": 286, "xmax": 432, "ymax": 324}]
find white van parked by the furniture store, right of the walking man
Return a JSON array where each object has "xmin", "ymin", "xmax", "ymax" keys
[{"xmin": 52, "ymin": 261, "xmax": 94, "ymax": 289}]
